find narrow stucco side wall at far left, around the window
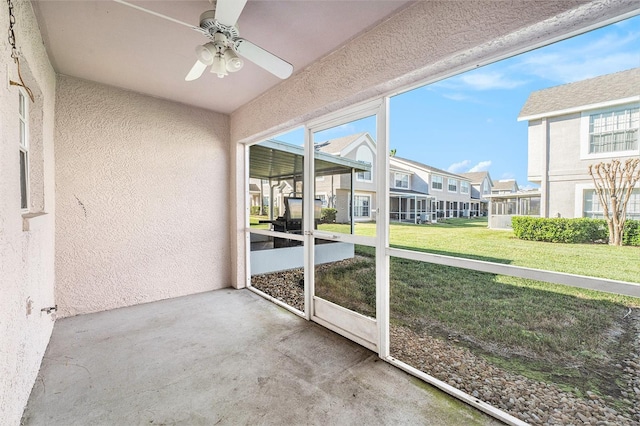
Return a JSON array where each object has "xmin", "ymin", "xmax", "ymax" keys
[{"xmin": 0, "ymin": 0, "xmax": 55, "ymax": 425}]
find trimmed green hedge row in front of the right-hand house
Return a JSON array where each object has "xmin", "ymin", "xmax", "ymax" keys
[{"xmin": 511, "ymin": 216, "xmax": 640, "ymax": 246}]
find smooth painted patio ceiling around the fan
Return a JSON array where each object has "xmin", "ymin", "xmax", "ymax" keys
[{"xmin": 32, "ymin": 0, "xmax": 408, "ymax": 113}]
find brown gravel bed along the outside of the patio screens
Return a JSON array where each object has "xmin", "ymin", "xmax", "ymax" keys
[{"xmin": 251, "ymin": 269, "xmax": 640, "ymax": 425}]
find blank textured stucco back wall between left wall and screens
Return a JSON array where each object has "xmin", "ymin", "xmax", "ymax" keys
[{"xmin": 55, "ymin": 76, "xmax": 230, "ymax": 316}]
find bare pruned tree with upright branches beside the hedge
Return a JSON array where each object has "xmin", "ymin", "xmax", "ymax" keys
[{"xmin": 589, "ymin": 158, "xmax": 640, "ymax": 246}]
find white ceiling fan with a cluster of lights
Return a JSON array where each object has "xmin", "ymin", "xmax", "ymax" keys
[{"xmin": 114, "ymin": 0, "xmax": 293, "ymax": 81}]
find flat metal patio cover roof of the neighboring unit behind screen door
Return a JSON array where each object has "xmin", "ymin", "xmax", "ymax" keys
[{"xmin": 249, "ymin": 140, "xmax": 371, "ymax": 180}]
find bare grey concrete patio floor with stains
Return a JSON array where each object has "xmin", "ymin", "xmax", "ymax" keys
[{"xmin": 23, "ymin": 289, "xmax": 500, "ymax": 425}]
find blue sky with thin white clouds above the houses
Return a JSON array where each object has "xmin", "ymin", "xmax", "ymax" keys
[{"xmin": 278, "ymin": 16, "xmax": 640, "ymax": 187}]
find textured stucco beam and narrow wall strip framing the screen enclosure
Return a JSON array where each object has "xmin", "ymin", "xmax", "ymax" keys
[{"xmin": 231, "ymin": 0, "xmax": 638, "ymax": 286}]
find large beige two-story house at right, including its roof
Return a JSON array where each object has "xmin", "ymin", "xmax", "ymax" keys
[{"xmin": 518, "ymin": 68, "xmax": 640, "ymax": 219}]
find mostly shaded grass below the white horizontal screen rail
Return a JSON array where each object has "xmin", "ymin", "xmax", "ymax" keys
[{"xmin": 316, "ymin": 246, "xmax": 640, "ymax": 397}]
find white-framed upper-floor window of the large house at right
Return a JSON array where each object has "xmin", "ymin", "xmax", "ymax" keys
[{"xmin": 580, "ymin": 102, "xmax": 640, "ymax": 159}]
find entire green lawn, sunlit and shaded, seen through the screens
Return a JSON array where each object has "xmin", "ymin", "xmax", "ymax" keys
[{"xmin": 304, "ymin": 219, "xmax": 640, "ymax": 398}]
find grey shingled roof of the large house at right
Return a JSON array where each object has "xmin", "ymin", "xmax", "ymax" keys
[{"xmin": 518, "ymin": 68, "xmax": 640, "ymax": 121}]
